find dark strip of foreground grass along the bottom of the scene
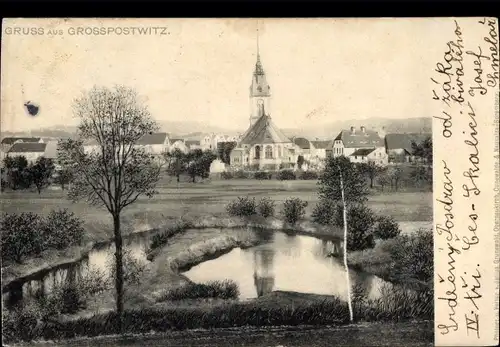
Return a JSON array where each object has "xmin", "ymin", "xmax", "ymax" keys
[{"xmin": 3, "ymin": 290, "xmax": 433, "ymax": 342}]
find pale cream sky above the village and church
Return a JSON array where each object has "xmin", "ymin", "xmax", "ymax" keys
[{"xmin": 1, "ymin": 18, "xmax": 446, "ymax": 131}]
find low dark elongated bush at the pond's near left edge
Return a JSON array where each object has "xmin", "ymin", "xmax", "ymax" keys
[{"xmin": 158, "ymin": 280, "xmax": 239, "ymax": 301}]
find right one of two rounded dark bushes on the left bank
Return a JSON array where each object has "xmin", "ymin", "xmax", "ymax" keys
[{"xmin": 42, "ymin": 209, "xmax": 85, "ymax": 249}]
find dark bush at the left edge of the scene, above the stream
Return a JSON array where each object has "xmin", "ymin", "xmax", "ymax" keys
[{"xmin": 0, "ymin": 212, "xmax": 43, "ymax": 263}]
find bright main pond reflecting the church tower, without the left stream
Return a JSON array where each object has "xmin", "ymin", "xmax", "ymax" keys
[{"xmin": 183, "ymin": 232, "xmax": 385, "ymax": 299}]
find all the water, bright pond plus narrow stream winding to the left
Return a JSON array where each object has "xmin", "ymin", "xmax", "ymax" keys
[{"xmin": 2, "ymin": 230, "xmax": 394, "ymax": 308}]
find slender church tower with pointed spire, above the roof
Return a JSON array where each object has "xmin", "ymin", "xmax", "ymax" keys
[{"xmin": 250, "ymin": 24, "xmax": 271, "ymax": 127}]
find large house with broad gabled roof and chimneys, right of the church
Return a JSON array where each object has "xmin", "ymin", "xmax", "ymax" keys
[{"xmin": 331, "ymin": 126, "xmax": 385, "ymax": 158}]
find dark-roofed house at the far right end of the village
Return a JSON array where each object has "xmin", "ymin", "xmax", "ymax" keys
[{"xmin": 385, "ymin": 133, "xmax": 432, "ymax": 163}]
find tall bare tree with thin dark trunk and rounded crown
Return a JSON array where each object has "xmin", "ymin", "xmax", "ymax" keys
[{"xmin": 59, "ymin": 86, "xmax": 162, "ymax": 331}]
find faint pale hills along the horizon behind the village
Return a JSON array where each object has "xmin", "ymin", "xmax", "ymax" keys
[{"xmin": 2, "ymin": 117, "xmax": 432, "ymax": 140}]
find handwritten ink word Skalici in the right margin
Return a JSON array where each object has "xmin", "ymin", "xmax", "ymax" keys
[{"xmin": 462, "ymin": 102, "xmax": 481, "ymax": 198}]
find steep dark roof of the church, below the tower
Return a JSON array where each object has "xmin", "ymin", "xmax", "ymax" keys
[{"xmin": 239, "ymin": 114, "xmax": 292, "ymax": 146}]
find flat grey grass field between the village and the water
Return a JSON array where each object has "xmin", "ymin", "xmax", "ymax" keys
[{"xmin": 0, "ymin": 179, "xmax": 432, "ymax": 240}]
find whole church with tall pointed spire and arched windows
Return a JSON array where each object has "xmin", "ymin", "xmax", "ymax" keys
[{"xmin": 230, "ymin": 44, "xmax": 297, "ymax": 170}]
